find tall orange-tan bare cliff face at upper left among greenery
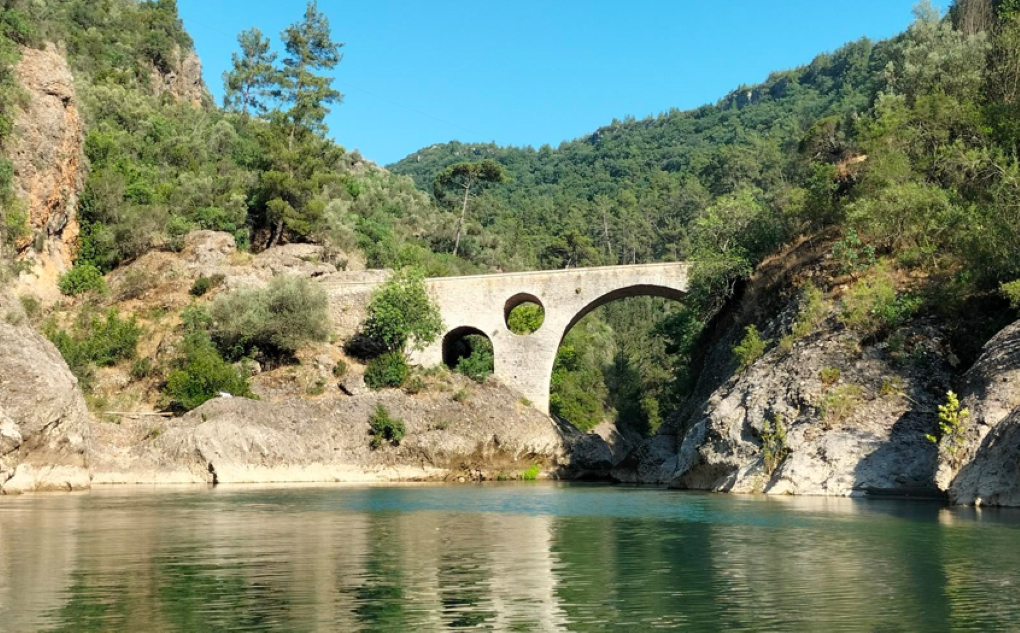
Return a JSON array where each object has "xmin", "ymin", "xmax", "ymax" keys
[{"xmin": 9, "ymin": 46, "xmax": 87, "ymax": 292}]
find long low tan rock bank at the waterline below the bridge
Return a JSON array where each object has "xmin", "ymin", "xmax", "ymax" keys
[{"xmin": 93, "ymin": 384, "xmax": 611, "ymax": 483}]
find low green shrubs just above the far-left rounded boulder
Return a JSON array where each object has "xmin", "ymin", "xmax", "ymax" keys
[{"xmin": 43, "ymin": 306, "xmax": 142, "ymax": 389}]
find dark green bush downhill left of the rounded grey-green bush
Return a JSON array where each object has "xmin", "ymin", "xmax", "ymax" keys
[{"xmin": 165, "ymin": 331, "xmax": 254, "ymax": 411}]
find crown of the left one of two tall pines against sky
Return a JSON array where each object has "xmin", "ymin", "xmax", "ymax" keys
[{"xmin": 223, "ymin": 29, "xmax": 278, "ymax": 116}]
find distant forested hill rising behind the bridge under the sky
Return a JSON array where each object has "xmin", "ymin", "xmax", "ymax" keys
[{"xmin": 390, "ymin": 34, "xmax": 899, "ymax": 267}]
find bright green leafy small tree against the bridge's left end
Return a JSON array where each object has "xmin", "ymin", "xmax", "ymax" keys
[{"xmin": 363, "ymin": 269, "xmax": 443, "ymax": 352}]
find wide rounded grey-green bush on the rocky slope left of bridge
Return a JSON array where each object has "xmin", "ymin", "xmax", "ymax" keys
[{"xmin": 209, "ymin": 276, "xmax": 329, "ymax": 360}]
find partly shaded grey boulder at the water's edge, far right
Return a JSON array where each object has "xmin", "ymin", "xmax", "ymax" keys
[{"xmin": 938, "ymin": 322, "xmax": 1020, "ymax": 506}]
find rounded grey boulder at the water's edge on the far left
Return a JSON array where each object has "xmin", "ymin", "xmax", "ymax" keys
[{"xmin": 0, "ymin": 323, "xmax": 90, "ymax": 494}]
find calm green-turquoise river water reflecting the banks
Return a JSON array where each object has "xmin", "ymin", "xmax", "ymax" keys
[{"xmin": 0, "ymin": 483, "xmax": 1020, "ymax": 632}]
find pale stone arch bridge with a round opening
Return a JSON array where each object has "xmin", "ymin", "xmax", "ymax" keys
[{"xmin": 330, "ymin": 263, "xmax": 689, "ymax": 413}]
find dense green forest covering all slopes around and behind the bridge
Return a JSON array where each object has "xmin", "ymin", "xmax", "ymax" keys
[{"xmin": 0, "ymin": 0, "xmax": 1020, "ymax": 433}]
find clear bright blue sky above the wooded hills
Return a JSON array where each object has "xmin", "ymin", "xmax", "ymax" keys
[{"xmin": 179, "ymin": 0, "xmax": 926, "ymax": 164}]
